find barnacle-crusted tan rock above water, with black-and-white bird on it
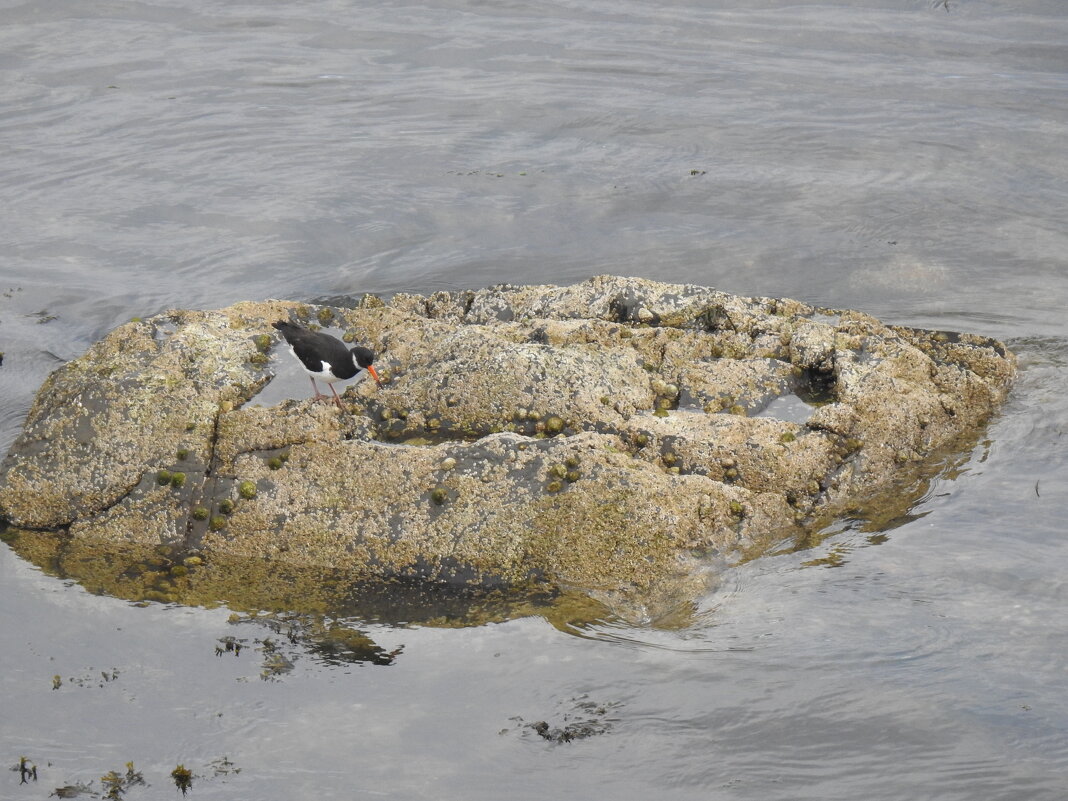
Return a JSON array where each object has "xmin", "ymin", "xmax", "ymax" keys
[{"xmin": 0, "ymin": 277, "xmax": 1015, "ymax": 615}]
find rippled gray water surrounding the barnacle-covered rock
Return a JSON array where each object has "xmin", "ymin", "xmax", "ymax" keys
[{"xmin": 0, "ymin": 0, "xmax": 1068, "ymax": 801}]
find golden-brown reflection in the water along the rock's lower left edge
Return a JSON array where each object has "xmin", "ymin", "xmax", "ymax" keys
[{"xmin": 2, "ymin": 529, "xmax": 611, "ymax": 657}]
